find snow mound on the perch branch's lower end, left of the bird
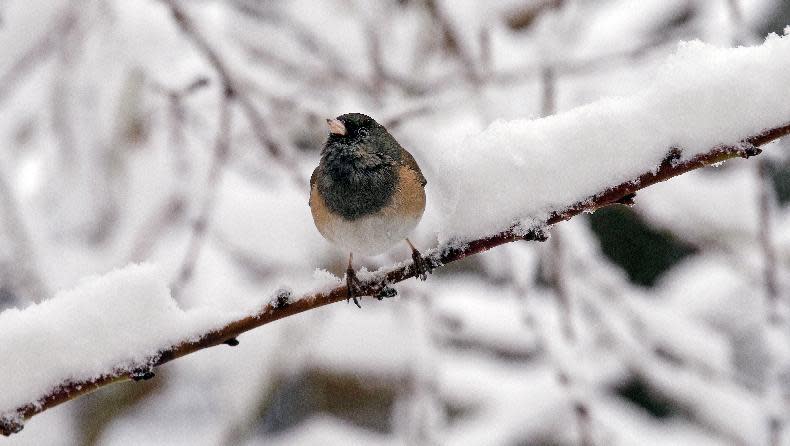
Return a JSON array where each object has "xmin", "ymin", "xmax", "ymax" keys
[{"xmin": 0, "ymin": 265, "xmax": 223, "ymax": 415}]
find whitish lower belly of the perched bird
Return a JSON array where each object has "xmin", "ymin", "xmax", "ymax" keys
[{"xmin": 324, "ymin": 214, "xmax": 422, "ymax": 255}]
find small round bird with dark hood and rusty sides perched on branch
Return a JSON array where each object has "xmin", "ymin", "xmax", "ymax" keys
[{"xmin": 310, "ymin": 113, "xmax": 431, "ymax": 306}]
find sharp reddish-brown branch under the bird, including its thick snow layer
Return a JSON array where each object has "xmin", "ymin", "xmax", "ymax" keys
[{"xmin": 0, "ymin": 35, "xmax": 790, "ymax": 435}]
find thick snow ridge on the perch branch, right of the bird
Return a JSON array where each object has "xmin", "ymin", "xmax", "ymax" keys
[{"xmin": 428, "ymin": 35, "xmax": 790, "ymax": 240}]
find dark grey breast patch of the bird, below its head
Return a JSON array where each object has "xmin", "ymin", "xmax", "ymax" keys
[{"xmin": 317, "ymin": 160, "xmax": 398, "ymax": 220}]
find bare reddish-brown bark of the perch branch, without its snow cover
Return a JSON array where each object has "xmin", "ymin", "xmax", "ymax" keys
[{"xmin": 0, "ymin": 122, "xmax": 790, "ymax": 435}]
